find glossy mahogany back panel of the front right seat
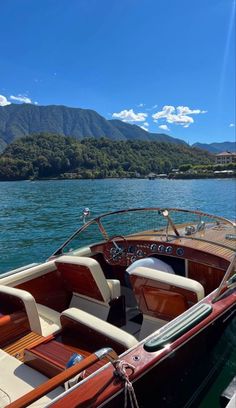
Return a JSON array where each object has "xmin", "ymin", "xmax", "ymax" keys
[{"xmin": 130, "ymin": 274, "xmax": 197, "ymax": 320}]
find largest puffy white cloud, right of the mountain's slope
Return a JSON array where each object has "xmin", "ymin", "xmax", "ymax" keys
[{"xmin": 152, "ymin": 105, "xmax": 207, "ymax": 128}]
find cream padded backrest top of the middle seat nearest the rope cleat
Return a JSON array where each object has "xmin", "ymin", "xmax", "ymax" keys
[{"xmin": 61, "ymin": 307, "xmax": 138, "ymax": 351}]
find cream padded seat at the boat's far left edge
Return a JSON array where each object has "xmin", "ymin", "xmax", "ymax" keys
[{"xmin": 0, "ymin": 285, "xmax": 61, "ymax": 336}]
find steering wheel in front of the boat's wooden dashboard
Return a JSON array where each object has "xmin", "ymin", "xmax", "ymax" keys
[{"xmin": 103, "ymin": 235, "xmax": 128, "ymax": 266}]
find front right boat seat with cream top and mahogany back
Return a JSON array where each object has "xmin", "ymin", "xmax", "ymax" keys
[{"xmin": 129, "ymin": 267, "xmax": 204, "ymax": 340}]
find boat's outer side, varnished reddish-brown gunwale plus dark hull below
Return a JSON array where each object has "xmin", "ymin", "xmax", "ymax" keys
[{"xmin": 50, "ymin": 294, "xmax": 236, "ymax": 408}]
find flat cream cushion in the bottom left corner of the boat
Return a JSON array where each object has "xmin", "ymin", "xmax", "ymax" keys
[{"xmin": 0, "ymin": 349, "xmax": 64, "ymax": 408}]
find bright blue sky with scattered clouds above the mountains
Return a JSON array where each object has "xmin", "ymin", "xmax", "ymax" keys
[{"xmin": 0, "ymin": 0, "xmax": 235, "ymax": 144}]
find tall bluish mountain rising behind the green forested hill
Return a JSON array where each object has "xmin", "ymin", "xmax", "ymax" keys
[{"xmin": 0, "ymin": 104, "xmax": 186, "ymax": 151}]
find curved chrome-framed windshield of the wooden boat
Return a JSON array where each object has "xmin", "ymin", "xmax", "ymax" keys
[{"xmin": 53, "ymin": 208, "xmax": 236, "ymax": 255}]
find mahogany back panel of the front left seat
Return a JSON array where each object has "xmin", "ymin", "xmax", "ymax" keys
[{"xmin": 57, "ymin": 262, "xmax": 104, "ymax": 301}]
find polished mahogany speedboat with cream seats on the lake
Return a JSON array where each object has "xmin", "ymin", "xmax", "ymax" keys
[{"xmin": 0, "ymin": 208, "xmax": 236, "ymax": 408}]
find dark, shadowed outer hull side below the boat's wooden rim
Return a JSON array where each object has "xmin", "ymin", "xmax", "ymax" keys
[{"xmin": 104, "ymin": 306, "xmax": 236, "ymax": 408}]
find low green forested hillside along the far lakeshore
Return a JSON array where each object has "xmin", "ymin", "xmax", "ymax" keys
[{"xmin": 0, "ymin": 133, "xmax": 214, "ymax": 180}]
